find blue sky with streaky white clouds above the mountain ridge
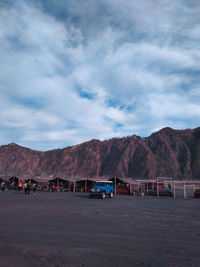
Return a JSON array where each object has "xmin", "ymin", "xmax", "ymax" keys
[{"xmin": 0, "ymin": 0, "xmax": 200, "ymax": 151}]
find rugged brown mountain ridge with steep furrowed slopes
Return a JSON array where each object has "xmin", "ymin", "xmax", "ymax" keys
[{"xmin": 0, "ymin": 128, "xmax": 200, "ymax": 179}]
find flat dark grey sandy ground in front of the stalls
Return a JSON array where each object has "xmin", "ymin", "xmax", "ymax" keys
[{"xmin": 0, "ymin": 191, "xmax": 200, "ymax": 267}]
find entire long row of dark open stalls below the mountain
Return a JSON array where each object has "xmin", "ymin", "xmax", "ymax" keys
[{"xmin": 0, "ymin": 176, "xmax": 200, "ymax": 198}]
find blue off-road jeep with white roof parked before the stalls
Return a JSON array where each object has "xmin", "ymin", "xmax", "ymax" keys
[{"xmin": 89, "ymin": 181, "xmax": 114, "ymax": 199}]
